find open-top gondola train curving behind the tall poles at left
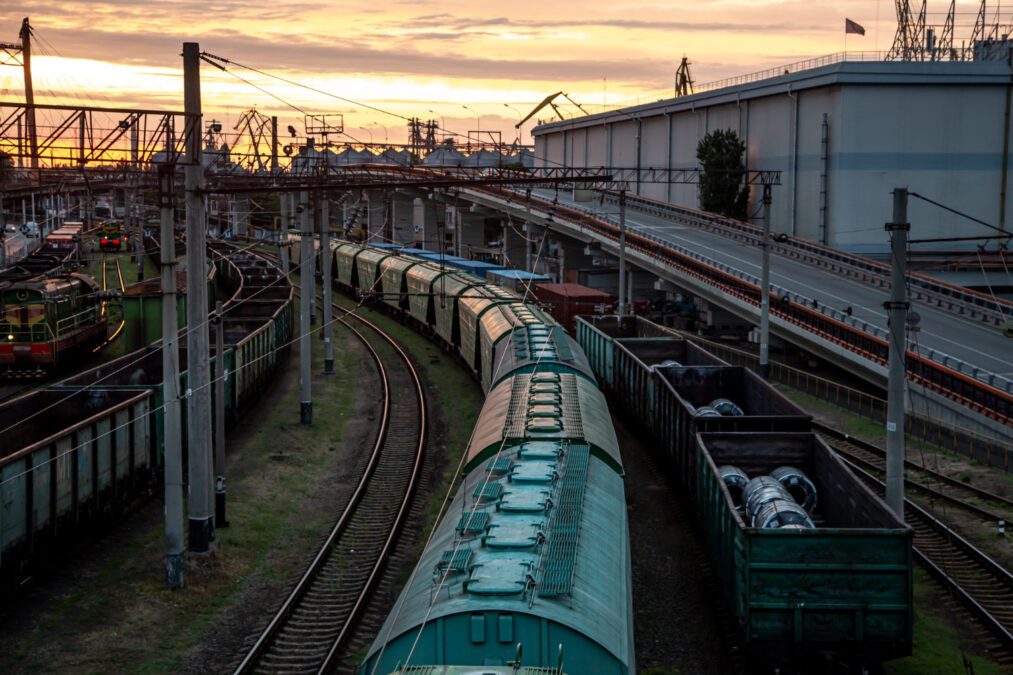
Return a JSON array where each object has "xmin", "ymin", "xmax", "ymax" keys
[{"xmin": 0, "ymin": 243, "xmax": 293, "ymax": 588}]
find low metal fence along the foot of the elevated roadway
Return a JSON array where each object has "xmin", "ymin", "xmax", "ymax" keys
[{"xmin": 680, "ymin": 331, "xmax": 1013, "ymax": 473}]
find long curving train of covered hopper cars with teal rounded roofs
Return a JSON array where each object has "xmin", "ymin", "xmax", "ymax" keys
[{"xmin": 333, "ymin": 244, "xmax": 636, "ymax": 675}]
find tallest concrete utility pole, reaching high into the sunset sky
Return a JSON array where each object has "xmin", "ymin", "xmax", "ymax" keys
[{"xmin": 183, "ymin": 43, "xmax": 215, "ymax": 553}]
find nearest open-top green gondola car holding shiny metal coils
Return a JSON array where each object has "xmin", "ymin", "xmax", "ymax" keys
[{"xmin": 695, "ymin": 433, "xmax": 914, "ymax": 662}]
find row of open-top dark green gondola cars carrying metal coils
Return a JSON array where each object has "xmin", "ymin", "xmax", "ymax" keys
[{"xmin": 577, "ymin": 316, "xmax": 914, "ymax": 672}]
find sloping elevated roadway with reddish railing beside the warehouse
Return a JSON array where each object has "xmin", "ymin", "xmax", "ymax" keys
[{"xmin": 462, "ymin": 185, "xmax": 1013, "ymax": 438}]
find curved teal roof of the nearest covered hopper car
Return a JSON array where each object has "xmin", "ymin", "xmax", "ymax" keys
[{"xmin": 367, "ymin": 441, "xmax": 633, "ymax": 673}]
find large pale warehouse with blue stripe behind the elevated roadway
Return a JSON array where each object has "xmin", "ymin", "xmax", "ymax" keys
[{"xmin": 532, "ymin": 59, "xmax": 1013, "ymax": 253}]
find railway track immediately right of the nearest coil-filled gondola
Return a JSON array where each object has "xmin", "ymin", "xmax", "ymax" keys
[{"xmin": 839, "ymin": 451, "xmax": 1013, "ymax": 667}]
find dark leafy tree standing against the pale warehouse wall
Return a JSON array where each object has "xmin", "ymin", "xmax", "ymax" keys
[{"xmin": 697, "ymin": 129, "xmax": 750, "ymax": 220}]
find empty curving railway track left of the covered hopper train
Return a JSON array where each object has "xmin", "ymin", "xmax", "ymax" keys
[{"xmin": 235, "ymin": 281, "xmax": 425, "ymax": 675}]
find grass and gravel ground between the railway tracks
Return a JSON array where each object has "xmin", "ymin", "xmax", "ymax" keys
[{"xmin": 0, "ymin": 285, "xmax": 1013, "ymax": 675}]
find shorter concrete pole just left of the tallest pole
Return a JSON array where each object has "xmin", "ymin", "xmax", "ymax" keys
[{"xmin": 158, "ymin": 164, "xmax": 183, "ymax": 588}]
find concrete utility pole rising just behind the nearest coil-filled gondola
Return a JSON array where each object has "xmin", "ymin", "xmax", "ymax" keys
[{"xmin": 883, "ymin": 188, "xmax": 911, "ymax": 520}]
